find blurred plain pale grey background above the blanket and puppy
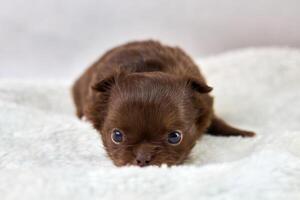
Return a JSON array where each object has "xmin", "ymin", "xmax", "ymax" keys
[{"xmin": 0, "ymin": 0, "xmax": 300, "ymax": 79}]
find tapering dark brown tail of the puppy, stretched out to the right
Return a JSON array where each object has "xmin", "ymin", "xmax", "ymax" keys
[{"xmin": 207, "ymin": 116, "xmax": 255, "ymax": 137}]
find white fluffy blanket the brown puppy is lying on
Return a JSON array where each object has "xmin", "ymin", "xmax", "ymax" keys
[{"xmin": 0, "ymin": 48, "xmax": 300, "ymax": 200}]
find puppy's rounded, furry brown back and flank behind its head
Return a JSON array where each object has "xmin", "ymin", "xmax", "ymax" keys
[{"xmin": 73, "ymin": 41, "xmax": 205, "ymax": 118}]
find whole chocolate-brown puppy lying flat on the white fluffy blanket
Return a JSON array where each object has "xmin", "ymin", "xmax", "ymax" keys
[{"xmin": 73, "ymin": 41, "xmax": 254, "ymax": 166}]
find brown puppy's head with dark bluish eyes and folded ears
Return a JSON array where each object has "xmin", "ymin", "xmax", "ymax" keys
[{"xmin": 87, "ymin": 72, "xmax": 212, "ymax": 166}]
